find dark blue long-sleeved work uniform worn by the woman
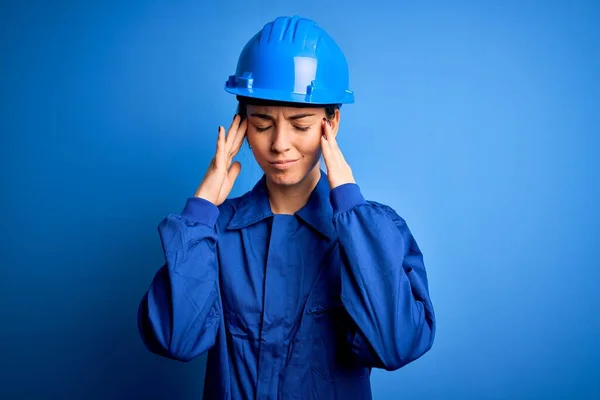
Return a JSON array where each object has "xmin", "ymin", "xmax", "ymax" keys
[{"xmin": 138, "ymin": 171, "xmax": 436, "ymax": 400}]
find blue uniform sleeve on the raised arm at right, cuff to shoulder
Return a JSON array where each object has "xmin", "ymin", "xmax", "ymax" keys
[{"xmin": 331, "ymin": 184, "xmax": 436, "ymax": 371}]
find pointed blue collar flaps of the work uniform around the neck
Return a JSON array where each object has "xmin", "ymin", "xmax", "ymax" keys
[{"xmin": 227, "ymin": 171, "xmax": 335, "ymax": 240}]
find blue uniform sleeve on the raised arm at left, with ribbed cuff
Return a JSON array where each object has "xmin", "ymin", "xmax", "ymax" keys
[{"xmin": 138, "ymin": 198, "xmax": 221, "ymax": 361}]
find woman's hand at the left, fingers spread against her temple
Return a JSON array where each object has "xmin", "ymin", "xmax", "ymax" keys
[{"xmin": 194, "ymin": 115, "xmax": 248, "ymax": 206}]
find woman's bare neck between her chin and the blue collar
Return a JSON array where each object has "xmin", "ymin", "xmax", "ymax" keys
[{"xmin": 267, "ymin": 164, "xmax": 321, "ymax": 215}]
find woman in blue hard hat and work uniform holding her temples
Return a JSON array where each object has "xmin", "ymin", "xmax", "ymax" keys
[{"xmin": 139, "ymin": 17, "xmax": 435, "ymax": 399}]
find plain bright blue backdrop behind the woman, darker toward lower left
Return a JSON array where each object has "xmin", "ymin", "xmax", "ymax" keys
[{"xmin": 0, "ymin": 0, "xmax": 600, "ymax": 400}]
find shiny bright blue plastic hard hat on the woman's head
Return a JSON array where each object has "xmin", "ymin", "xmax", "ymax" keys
[{"xmin": 225, "ymin": 16, "xmax": 354, "ymax": 104}]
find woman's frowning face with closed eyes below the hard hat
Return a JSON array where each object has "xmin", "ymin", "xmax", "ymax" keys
[{"xmin": 246, "ymin": 105, "xmax": 339, "ymax": 186}]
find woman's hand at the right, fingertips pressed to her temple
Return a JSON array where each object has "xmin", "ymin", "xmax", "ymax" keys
[{"xmin": 321, "ymin": 119, "xmax": 355, "ymax": 189}]
